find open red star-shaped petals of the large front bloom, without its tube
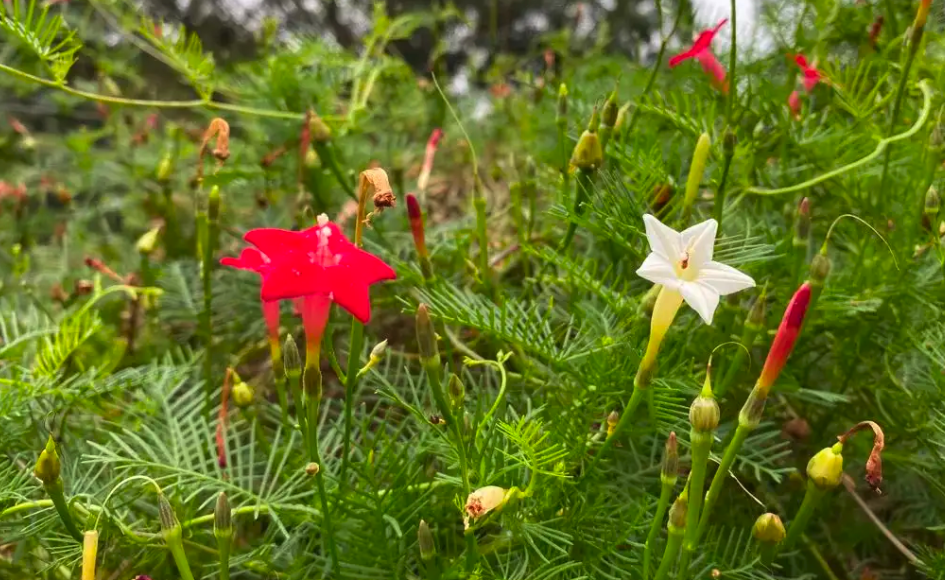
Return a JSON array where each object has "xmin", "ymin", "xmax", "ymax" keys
[{"xmin": 240, "ymin": 214, "xmax": 397, "ymax": 323}]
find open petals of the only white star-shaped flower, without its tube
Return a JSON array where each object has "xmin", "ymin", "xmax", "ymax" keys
[{"xmin": 637, "ymin": 214, "xmax": 755, "ymax": 324}]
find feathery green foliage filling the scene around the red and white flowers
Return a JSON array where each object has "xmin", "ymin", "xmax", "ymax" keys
[{"xmin": 0, "ymin": 0, "xmax": 945, "ymax": 580}]
